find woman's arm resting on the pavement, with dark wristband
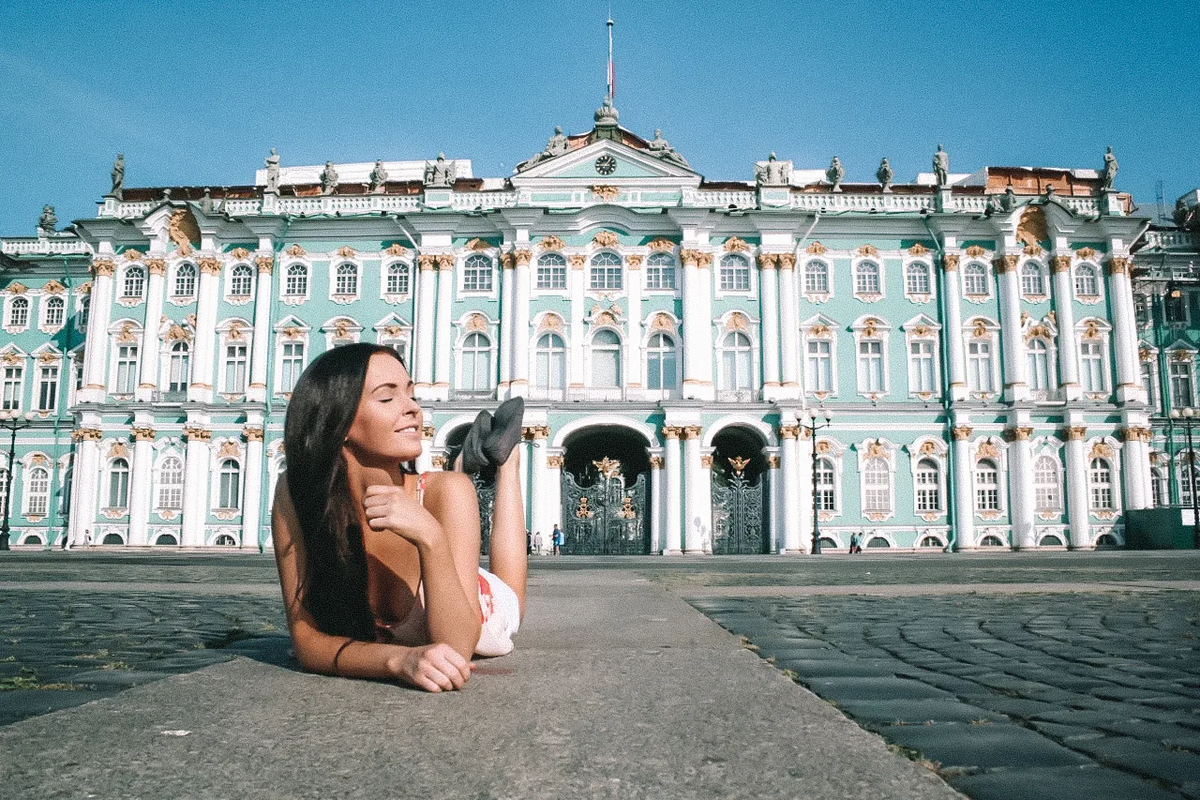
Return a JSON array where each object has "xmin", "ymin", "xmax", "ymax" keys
[{"xmin": 271, "ymin": 476, "xmax": 478, "ymax": 692}]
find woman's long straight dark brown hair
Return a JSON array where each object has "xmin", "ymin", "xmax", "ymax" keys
[{"xmin": 283, "ymin": 343, "xmax": 404, "ymax": 640}]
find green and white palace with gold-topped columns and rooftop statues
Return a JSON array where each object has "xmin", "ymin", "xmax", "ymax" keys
[{"xmin": 0, "ymin": 103, "xmax": 1176, "ymax": 555}]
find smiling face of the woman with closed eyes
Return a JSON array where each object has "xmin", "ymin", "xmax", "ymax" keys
[{"xmin": 346, "ymin": 353, "xmax": 421, "ymax": 468}]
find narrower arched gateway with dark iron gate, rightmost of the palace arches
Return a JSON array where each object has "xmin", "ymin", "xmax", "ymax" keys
[{"xmin": 712, "ymin": 426, "xmax": 770, "ymax": 555}]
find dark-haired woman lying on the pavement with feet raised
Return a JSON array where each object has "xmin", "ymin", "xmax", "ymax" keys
[{"xmin": 271, "ymin": 344, "xmax": 528, "ymax": 692}]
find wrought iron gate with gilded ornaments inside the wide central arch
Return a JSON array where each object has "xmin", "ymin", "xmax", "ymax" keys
[{"xmin": 563, "ymin": 458, "xmax": 650, "ymax": 555}]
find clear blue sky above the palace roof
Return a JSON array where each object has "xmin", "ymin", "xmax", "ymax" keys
[{"xmin": 0, "ymin": 0, "xmax": 1200, "ymax": 235}]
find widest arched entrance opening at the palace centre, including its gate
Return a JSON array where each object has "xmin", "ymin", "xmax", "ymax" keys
[{"xmin": 563, "ymin": 427, "xmax": 650, "ymax": 555}]
